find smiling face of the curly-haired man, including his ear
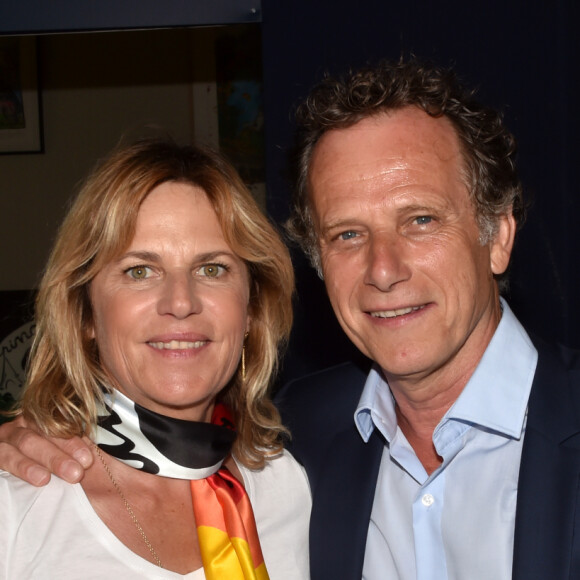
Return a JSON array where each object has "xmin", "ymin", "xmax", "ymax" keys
[{"xmin": 309, "ymin": 107, "xmax": 514, "ymax": 390}]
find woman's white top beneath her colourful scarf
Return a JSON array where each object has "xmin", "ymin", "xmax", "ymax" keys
[{"xmin": 0, "ymin": 452, "xmax": 311, "ymax": 580}]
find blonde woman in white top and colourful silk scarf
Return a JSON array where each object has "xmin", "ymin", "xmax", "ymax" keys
[{"xmin": 0, "ymin": 141, "xmax": 310, "ymax": 580}]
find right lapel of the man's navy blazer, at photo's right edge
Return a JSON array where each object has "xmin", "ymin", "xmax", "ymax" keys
[{"xmin": 513, "ymin": 348, "xmax": 580, "ymax": 580}]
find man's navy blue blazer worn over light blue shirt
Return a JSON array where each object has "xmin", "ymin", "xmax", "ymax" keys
[{"xmin": 276, "ymin": 343, "xmax": 580, "ymax": 580}]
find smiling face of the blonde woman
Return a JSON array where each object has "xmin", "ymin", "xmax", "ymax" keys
[{"xmin": 90, "ymin": 182, "xmax": 250, "ymax": 421}]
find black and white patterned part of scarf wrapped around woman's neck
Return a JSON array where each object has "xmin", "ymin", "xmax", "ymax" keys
[{"xmin": 93, "ymin": 390, "xmax": 236, "ymax": 480}]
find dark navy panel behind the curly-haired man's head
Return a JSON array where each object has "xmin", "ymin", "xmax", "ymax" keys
[{"xmin": 262, "ymin": 0, "xmax": 580, "ymax": 380}]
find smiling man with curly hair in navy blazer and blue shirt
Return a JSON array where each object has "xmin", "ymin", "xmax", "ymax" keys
[{"xmin": 0, "ymin": 61, "xmax": 580, "ymax": 580}]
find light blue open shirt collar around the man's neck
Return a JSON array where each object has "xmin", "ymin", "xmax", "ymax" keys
[{"xmin": 354, "ymin": 298, "xmax": 538, "ymax": 442}]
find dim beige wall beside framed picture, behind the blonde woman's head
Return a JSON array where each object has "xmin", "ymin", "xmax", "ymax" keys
[{"xmin": 0, "ymin": 29, "xmax": 204, "ymax": 290}]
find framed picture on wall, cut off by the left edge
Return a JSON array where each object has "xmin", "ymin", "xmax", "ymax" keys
[{"xmin": 0, "ymin": 36, "xmax": 43, "ymax": 154}]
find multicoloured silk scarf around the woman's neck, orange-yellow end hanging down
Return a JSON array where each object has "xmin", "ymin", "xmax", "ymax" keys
[{"xmin": 94, "ymin": 391, "xmax": 268, "ymax": 580}]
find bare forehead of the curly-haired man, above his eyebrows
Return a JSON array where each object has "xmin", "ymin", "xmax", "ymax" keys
[{"xmin": 309, "ymin": 107, "xmax": 465, "ymax": 212}]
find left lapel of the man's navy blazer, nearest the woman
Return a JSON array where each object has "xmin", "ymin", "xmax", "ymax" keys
[{"xmin": 310, "ymin": 424, "xmax": 384, "ymax": 580}]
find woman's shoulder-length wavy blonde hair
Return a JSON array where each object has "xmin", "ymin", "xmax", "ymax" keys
[{"xmin": 18, "ymin": 139, "xmax": 294, "ymax": 468}]
